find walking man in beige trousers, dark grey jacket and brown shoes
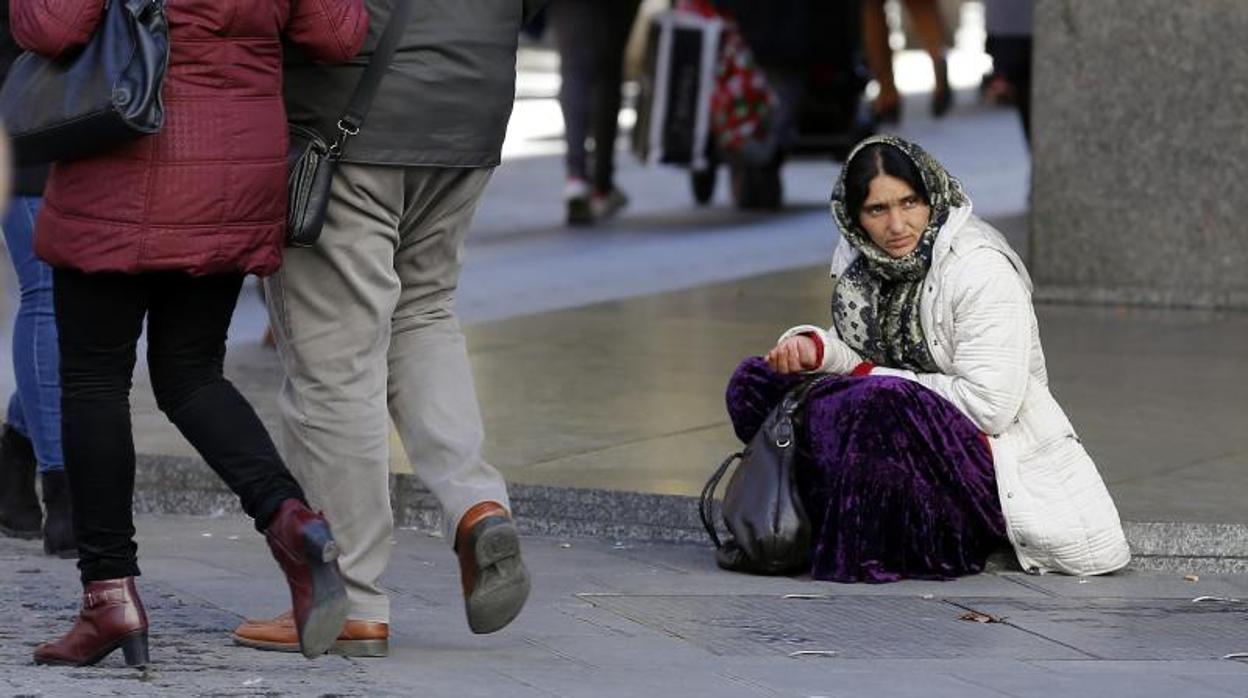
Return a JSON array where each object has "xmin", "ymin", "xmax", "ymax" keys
[{"xmin": 233, "ymin": 0, "xmax": 543, "ymax": 657}]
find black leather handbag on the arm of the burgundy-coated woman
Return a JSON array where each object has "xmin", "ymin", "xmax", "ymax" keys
[{"xmin": 0, "ymin": 0, "xmax": 168, "ymax": 165}]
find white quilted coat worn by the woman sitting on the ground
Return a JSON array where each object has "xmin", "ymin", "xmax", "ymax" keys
[{"xmin": 784, "ymin": 205, "xmax": 1131, "ymax": 574}]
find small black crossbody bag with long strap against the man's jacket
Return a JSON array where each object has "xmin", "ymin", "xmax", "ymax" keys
[{"xmin": 286, "ymin": 0, "xmax": 412, "ymax": 247}]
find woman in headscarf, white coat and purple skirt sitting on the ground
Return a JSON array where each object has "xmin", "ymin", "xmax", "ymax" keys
[{"xmin": 728, "ymin": 136, "xmax": 1131, "ymax": 582}]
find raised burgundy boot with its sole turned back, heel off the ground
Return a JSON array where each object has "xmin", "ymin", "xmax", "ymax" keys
[{"xmin": 265, "ymin": 498, "xmax": 347, "ymax": 659}]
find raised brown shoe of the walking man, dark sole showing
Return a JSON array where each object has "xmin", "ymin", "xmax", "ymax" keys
[{"xmin": 456, "ymin": 502, "xmax": 529, "ymax": 634}]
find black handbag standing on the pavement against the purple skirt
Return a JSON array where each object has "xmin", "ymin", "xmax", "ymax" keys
[{"xmin": 698, "ymin": 376, "xmax": 826, "ymax": 574}]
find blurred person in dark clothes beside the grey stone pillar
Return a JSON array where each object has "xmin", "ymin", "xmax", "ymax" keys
[{"xmin": 983, "ymin": 0, "xmax": 1032, "ymax": 145}]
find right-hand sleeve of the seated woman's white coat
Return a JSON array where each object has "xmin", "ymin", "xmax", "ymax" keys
[{"xmin": 871, "ymin": 248, "xmax": 1033, "ymax": 435}]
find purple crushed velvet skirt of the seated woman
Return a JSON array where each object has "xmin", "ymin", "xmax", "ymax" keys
[{"xmin": 728, "ymin": 357, "xmax": 1006, "ymax": 582}]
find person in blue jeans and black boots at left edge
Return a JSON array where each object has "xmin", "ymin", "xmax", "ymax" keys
[{"xmin": 0, "ymin": 1, "xmax": 77, "ymax": 557}]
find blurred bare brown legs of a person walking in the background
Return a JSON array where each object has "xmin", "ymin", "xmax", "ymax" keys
[{"xmin": 862, "ymin": 0, "xmax": 953, "ymax": 124}]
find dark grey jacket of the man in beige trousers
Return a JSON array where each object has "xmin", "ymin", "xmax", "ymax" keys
[{"xmin": 285, "ymin": 0, "xmax": 545, "ymax": 167}]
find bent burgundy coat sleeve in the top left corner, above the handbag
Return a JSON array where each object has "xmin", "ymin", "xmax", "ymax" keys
[{"xmin": 9, "ymin": 0, "xmax": 104, "ymax": 59}]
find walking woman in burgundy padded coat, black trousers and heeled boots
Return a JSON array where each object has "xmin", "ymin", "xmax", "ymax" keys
[{"xmin": 10, "ymin": 0, "xmax": 367, "ymax": 666}]
